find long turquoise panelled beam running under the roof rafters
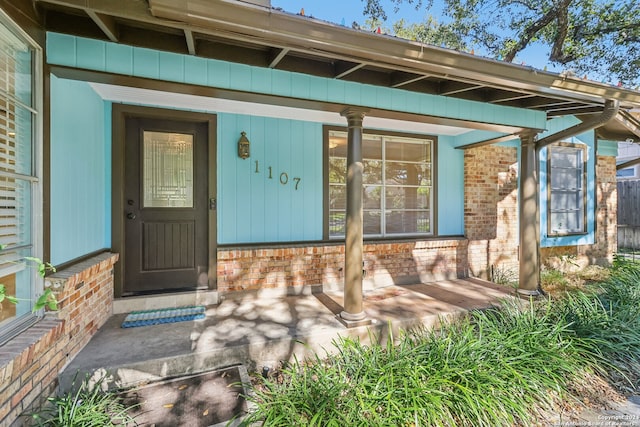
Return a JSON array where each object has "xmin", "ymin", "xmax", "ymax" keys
[{"xmin": 47, "ymin": 33, "xmax": 546, "ymax": 129}]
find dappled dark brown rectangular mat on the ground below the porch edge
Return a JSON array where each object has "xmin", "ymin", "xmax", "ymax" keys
[{"xmin": 122, "ymin": 365, "xmax": 249, "ymax": 427}]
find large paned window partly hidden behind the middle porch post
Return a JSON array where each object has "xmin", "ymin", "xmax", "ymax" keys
[{"xmin": 327, "ymin": 130, "xmax": 435, "ymax": 238}]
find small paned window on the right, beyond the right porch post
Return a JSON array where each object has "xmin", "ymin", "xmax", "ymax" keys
[{"xmin": 547, "ymin": 144, "xmax": 587, "ymax": 236}]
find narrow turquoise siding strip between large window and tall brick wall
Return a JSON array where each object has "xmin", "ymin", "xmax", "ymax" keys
[{"xmin": 436, "ymin": 136, "xmax": 464, "ymax": 236}]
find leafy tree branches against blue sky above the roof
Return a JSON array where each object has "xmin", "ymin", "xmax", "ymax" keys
[{"xmin": 363, "ymin": 0, "xmax": 640, "ymax": 85}]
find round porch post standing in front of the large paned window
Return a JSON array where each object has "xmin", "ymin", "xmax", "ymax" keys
[{"xmin": 340, "ymin": 108, "xmax": 367, "ymax": 327}]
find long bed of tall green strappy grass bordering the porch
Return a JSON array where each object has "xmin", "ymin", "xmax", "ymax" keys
[{"xmin": 244, "ymin": 260, "xmax": 640, "ymax": 427}]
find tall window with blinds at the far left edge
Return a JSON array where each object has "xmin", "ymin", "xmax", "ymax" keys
[{"xmin": 0, "ymin": 15, "xmax": 39, "ymax": 334}]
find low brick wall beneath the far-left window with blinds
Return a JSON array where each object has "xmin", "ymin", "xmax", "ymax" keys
[{"xmin": 0, "ymin": 253, "xmax": 118, "ymax": 426}]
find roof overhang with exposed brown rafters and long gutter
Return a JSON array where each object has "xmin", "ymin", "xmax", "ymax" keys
[{"xmin": 34, "ymin": 0, "xmax": 640, "ymax": 141}]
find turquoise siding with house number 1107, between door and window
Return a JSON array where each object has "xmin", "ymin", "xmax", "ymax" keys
[{"xmin": 217, "ymin": 113, "xmax": 323, "ymax": 244}]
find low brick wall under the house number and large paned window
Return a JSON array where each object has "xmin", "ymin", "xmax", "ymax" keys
[{"xmin": 218, "ymin": 239, "xmax": 467, "ymax": 292}]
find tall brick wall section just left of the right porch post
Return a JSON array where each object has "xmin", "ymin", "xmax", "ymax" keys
[{"xmin": 464, "ymin": 145, "xmax": 518, "ymax": 278}]
